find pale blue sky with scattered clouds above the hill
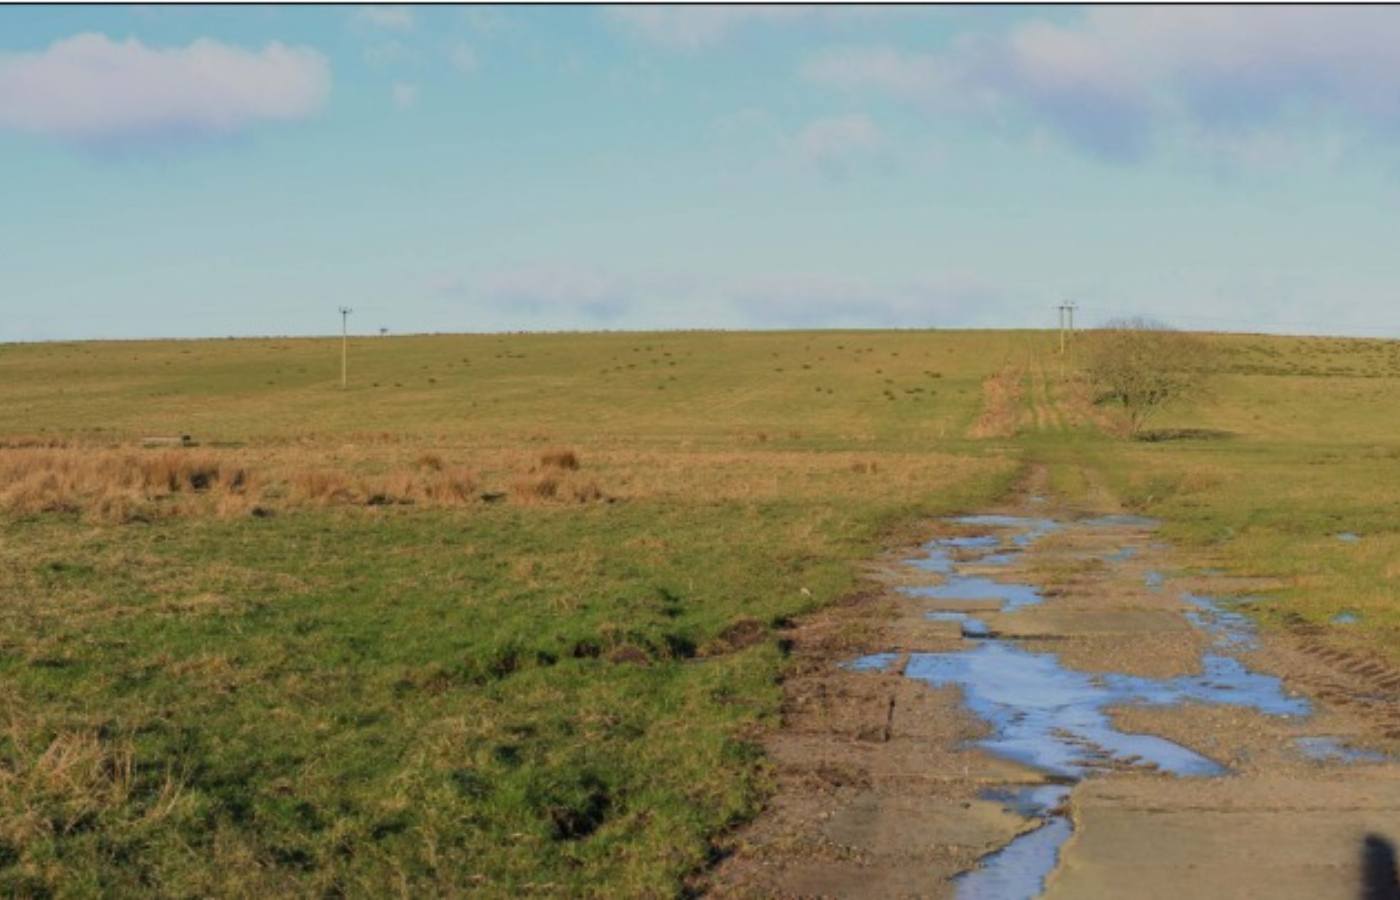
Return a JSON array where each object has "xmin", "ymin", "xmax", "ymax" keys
[{"xmin": 0, "ymin": 6, "xmax": 1400, "ymax": 342}]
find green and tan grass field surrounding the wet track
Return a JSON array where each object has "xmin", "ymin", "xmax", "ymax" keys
[{"xmin": 0, "ymin": 332, "xmax": 1400, "ymax": 896}]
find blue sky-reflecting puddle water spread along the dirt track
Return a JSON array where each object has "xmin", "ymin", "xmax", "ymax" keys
[{"xmin": 847, "ymin": 515, "xmax": 1327, "ymax": 899}]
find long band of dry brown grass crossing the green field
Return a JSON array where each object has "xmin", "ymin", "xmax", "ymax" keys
[{"xmin": 0, "ymin": 438, "xmax": 1008, "ymax": 522}]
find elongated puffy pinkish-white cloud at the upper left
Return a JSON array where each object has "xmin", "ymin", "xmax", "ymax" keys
[{"xmin": 0, "ymin": 34, "xmax": 330, "ymax": 147}]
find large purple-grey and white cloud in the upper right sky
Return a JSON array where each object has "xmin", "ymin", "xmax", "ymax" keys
[{"xmin": 802, "ymin": 6, "xmax": 1400, "ymax": 161}]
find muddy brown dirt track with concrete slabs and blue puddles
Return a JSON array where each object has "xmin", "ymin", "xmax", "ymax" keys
[{"xmin": 706, "ymin": 479, "xmax": 1400, "ymax": 900}]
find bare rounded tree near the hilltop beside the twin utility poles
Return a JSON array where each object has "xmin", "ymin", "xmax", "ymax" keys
[{"xmin": 1084, "ymin": 319, "xmax": 1214, "ymax": 434}]
